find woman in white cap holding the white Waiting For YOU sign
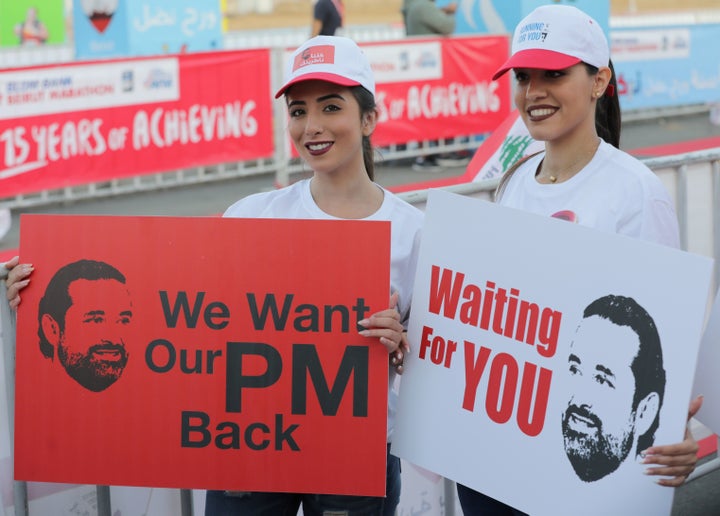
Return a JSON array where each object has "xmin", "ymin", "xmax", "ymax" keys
[{"xmin": 458, "ymin": 5, "xmax": 702, "ymax": 516}]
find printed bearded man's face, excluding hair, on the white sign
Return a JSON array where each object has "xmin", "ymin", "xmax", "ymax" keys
[{"xmin": 562, "ymin": 316, "xmax": 640, "ymax": 482}]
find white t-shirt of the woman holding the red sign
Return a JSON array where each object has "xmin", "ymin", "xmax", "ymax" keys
[{"xmin": 223, "ymin": 179, "xmax": 424, "ymax": 442}]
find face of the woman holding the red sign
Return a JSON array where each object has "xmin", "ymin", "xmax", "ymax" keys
[{"xmin": 286, "ymin": 80, "xmax": 376, "ymax": 177}]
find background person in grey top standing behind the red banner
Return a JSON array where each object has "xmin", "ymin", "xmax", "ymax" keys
[{"xmin": 401, "ymin": 0, "xmax": 470, "ymax": 172}]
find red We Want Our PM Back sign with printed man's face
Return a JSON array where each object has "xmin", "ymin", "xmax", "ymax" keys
[{"xmin": 15, "ymin": 215, "xmax": 390, "ymax": 496}]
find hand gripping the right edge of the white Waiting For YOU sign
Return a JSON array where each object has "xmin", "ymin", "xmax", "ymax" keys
[{"xmin": 640, "ymin": 396, "xmax": 703, "ymax": 487}]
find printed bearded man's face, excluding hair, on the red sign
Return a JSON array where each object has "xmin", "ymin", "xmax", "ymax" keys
[{"xmin": 43, "ymin": 279, "xmax": 132, "ymax": 392}]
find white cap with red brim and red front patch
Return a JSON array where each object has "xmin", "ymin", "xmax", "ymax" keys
[{"xmin": 275, "ymin": 36, "xmax": 375, "ymax": 98}]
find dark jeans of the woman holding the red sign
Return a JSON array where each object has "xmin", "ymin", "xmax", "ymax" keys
[{"xmin": 205, "ymin": 446, "xmax": 400, "ymax": 516}]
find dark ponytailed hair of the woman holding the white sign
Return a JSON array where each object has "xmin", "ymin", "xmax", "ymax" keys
[{"xmin": 495, "ymin": 59, "xmax": 622, "ymax": 200}]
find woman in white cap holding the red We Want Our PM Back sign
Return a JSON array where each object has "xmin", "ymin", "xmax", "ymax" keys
[{"xmin": 205, "ymin": 36, "xmax": 423, "ymax": 516}]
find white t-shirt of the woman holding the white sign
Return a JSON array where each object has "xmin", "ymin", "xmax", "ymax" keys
[{"xmin": 498, "ymin": 140, "xmax": 680, "ymax": 248}]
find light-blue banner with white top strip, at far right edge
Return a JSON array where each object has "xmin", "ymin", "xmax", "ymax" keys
[{"xmin": 611, "ymin": 24, "xmax": 720, "ymax": 111}]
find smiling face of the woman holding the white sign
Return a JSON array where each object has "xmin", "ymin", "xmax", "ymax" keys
[{"xmin": 513, "ymin": 63, "xmax": 609, "ymax": 146}]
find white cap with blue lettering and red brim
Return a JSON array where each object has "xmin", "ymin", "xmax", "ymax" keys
[{"xmin": 493, "ymin": 4, "xmax": 610, "ymax": 80}]
